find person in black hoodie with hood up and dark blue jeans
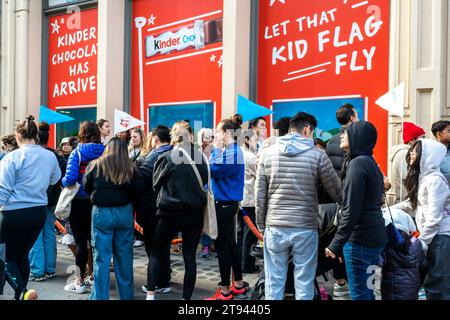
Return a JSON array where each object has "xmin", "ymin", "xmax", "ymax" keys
[{"xmin": 325, "ymin": 121, "xmax": 387, "ymax": 300}]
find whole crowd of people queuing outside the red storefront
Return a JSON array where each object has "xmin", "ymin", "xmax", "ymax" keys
[{"xmin": 0, "ymin": 104, "xmax": 450, "ymax": 301}]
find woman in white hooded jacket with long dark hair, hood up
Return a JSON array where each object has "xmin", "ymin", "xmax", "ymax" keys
[{"xmin": 394, "ymin": 139, "xmax": 450, "ymax": 300}]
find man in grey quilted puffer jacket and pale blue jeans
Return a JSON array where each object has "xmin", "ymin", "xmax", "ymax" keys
[{"xmin": 255, "ymin": 112, "xmax": 342, "ymax": 300}]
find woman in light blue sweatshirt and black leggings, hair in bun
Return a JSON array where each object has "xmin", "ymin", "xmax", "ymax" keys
[{"xmin": 0, "ymin": 116, "xmax": 61, "ymax": 300}]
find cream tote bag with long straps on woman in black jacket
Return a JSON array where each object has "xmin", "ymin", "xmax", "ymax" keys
[{"xmin": 177, "ymin": 148, "xmax": 219, "ymax": 240}]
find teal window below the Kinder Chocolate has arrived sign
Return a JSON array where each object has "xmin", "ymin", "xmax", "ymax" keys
[{"xmin": 56, "ymin": 108, "xmax": 97, "ymax": 145}]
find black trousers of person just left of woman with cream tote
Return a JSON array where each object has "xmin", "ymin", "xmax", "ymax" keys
[{"xmin": 140, "ymin": 217, "xmax": 171, "ymax": 288}]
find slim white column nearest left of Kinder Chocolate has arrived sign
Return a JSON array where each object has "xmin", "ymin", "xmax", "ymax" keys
[{"xmin": 14, "ymin": 0, "xmax": 30, "ymax": 121}]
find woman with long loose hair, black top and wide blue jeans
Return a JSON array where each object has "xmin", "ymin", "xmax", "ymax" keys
[{"xmin": 83, "ymin": 138, "xmax": 144, "ymax": 300}]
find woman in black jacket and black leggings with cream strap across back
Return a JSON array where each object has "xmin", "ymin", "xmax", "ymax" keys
[{"xmin": 147, "ymin": 121, "xmax": 208, "ymax": 300}]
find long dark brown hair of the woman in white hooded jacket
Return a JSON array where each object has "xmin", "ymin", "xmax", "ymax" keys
[{"xmin": 405, "ymin": 140, "xmax": 422, "ymax": 210}]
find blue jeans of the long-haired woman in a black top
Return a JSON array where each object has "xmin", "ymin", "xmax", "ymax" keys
[{"xmin": 90, "ymin": 205, "xmax": 134, "ymax": 300}]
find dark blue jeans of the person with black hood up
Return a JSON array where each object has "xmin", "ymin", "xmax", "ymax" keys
[{"xmin": 344, "ymin": 242, "xmax": 384, "ymax": 300}]
